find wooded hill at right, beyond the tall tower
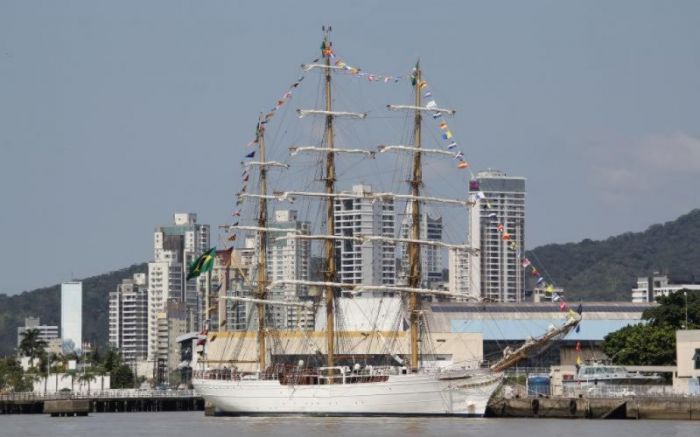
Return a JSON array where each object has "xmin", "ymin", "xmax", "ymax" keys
[{"xmin": 528, "ymin": 209, "xmax": 700, "ymax": 301}]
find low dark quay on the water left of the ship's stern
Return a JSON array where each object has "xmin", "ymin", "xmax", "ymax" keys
[{"xmin": 0, "ymin": 390, "xmax": 204, "ymax": 415}]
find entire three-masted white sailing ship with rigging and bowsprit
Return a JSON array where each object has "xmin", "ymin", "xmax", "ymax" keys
[{"xmin": 192, "ymin": 27, "xmax": 580, "ymax": 416}]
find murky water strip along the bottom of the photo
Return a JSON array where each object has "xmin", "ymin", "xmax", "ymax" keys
[{"xmin": 0, "ymin": 412, "xmax": 700, "ymax": 437}]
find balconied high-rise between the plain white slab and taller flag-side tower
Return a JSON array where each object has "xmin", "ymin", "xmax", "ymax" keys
[{"xmin": 109, "ymin": 273, "xmax": 148, "ymax": 366}]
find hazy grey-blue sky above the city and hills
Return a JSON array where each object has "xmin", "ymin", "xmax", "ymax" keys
[{"xmin": 0, "ymin": 0, "xmax": 700, "ymax": 294}]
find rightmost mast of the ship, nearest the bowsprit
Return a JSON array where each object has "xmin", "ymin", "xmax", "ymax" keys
[{"xmin": 408, "ymin": 61, "xmax": 423, "ymax": 372}]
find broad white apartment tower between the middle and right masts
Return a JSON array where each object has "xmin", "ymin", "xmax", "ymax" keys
[{"xmin": 334, "ymin": 185, "xmax": 396, "ymax": 285}]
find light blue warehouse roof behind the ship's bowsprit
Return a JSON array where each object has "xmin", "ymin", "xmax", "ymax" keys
[{"xmin": 450, "ymin": 318, "xmax": 640, "ymax": 341}]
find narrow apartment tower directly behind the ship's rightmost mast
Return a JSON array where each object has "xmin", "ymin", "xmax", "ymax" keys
[{"xmin": 401, "ymin": 203, "xmax": 443, "ymax": 288}]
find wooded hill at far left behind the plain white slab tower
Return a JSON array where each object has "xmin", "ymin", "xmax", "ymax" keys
[{"xmin": 0, "ymin": 263, "xmax": 148, "ymax": 356}]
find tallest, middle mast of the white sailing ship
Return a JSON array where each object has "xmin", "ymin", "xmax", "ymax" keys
[{"xmin": 321, "ymin": 26, "xmax": 336, "ymax": 372}]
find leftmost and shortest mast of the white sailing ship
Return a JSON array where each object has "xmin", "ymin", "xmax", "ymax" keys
[{"xmin": 256, "ymin": 122, "xmax": 267, "ymax": 371}]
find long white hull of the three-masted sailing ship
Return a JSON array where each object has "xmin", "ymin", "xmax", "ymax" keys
[{"xmin": 192, "ymin": 374, "xmax": 501, "ymax": 416}]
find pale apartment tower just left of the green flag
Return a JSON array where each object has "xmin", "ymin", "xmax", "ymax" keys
[{"xmin": 148, "ymin": 213, "xmax": 210, "ymax": 359}]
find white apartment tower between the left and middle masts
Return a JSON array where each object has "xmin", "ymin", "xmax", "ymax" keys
[{"xmin": 267, "ymin": 210, "xmax": 314, "ymax": 329}]
